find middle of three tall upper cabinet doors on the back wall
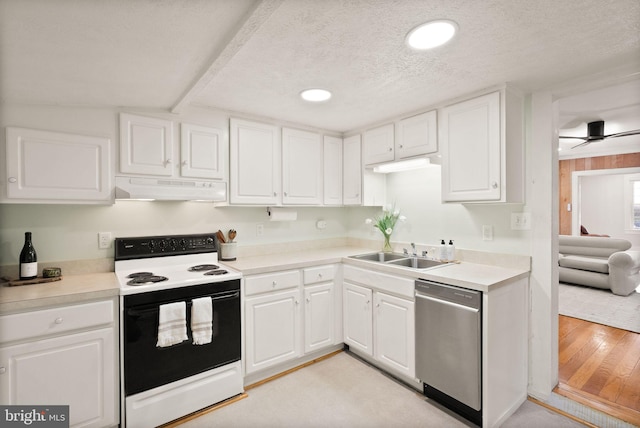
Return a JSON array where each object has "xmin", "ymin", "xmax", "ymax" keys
[{"xmin": 282, "ymin": 128, "xmax": 323, "ymax": 205}]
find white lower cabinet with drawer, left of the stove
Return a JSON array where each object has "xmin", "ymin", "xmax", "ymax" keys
[{"xmin": 0, "ymin": 300, "xmax": 118, "ymax": 427}]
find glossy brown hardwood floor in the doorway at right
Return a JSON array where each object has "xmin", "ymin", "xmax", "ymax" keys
[{"xmin": 554, "ymin": 315, "xmax": 640, "ymax": 426}]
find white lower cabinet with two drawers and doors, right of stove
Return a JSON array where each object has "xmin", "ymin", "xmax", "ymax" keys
[{"xmin": 244, "ymin": 265, "xmax": 342, "ymax": 374}]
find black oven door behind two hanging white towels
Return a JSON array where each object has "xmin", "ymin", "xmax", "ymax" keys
[{"xmin": 123, "ymin": 279, "xmax": 241, "ymax": 396}]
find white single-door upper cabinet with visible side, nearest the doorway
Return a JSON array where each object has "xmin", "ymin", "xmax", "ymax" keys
[{"xmin": 439, "ymin": 89, "xmax": 524, "ymax": 203}]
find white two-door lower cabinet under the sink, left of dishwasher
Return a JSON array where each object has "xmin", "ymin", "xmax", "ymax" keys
[{"xmin": 343, "ymin": 266, "xmax": 415, "ymax": 379}]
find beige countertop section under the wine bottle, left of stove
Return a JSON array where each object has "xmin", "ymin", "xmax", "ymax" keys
[{"xmin": 0, "ymin": 272, "xmax": 120, "ymax": 314}]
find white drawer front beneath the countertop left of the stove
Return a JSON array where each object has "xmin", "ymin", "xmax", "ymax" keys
[{"xmin": 0, "ymin": 300, "xmax": 114, "ymax": 343}]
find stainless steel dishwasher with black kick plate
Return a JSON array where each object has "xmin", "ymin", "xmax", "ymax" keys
[{"xmin": 415, "ymin": 279, "xmax": 482, "ymax": 425}]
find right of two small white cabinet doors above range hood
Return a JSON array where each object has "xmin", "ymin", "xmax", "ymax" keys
[{"xmin": 180, "ymin": 123, "xmax": 226, "ymax": 179}]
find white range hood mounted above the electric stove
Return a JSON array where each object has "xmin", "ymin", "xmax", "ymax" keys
[{"xmin": 116, "ymin": 177, "xmax": 227, "ymax": 201}]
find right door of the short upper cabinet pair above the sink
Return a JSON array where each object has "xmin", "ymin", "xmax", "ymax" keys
[{"xmin": 396, "ymin": 110, "xmax": 438, "ymax": 159}]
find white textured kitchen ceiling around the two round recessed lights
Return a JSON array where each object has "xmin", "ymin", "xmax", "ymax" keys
[{"xmin": 0, "ymin": 0, "xmax": 640, "ymax": 144}]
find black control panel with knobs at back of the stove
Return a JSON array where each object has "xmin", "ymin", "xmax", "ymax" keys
[{"xmin": 115, "ymin": 233, "xmax": 218, "ymax": 261}]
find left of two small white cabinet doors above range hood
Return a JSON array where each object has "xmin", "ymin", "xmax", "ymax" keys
[{"xmin": 120, "ymin": 113, "xmax": 176, "ymax": 176}]
